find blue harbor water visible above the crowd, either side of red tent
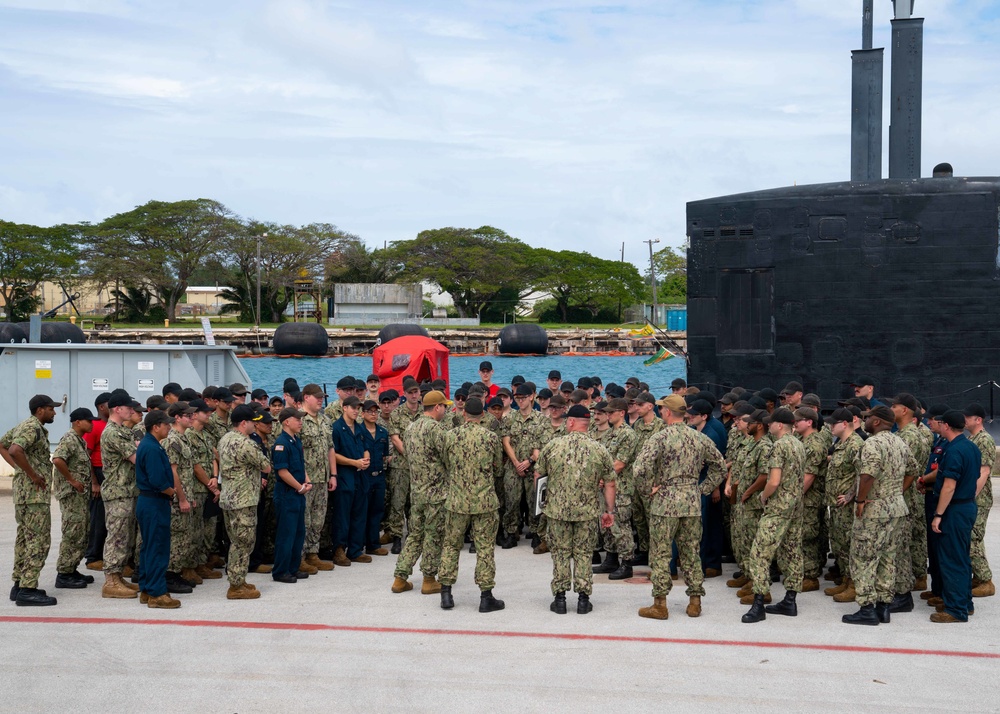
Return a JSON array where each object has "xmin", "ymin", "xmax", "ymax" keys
[{"xmin": 240, "ymin": 355, "xmax": 687, "ymax": 398}]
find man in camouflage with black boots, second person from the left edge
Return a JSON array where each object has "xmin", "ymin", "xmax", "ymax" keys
[{"xmin": 52, "ymin": 408, "xmax": 97, "ymax": 588}]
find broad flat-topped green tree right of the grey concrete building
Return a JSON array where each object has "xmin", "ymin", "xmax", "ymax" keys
[{"xmin": 387, "ymin": 226, "xmax": 540, "ymax": 317}]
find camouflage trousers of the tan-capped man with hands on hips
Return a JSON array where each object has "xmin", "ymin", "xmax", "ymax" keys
[{"xmin": 649, "ymin": 515, "xmax": 705, "ymax": 597}]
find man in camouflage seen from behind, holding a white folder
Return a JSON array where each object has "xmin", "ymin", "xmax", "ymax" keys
[{"xmin": 535, "ymin": 404, "xmax": 615, "ymax": 615}]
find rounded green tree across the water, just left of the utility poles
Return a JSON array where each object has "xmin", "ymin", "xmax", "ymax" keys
[{"xmin": 534, "ymin": 248, "xmax": 643, "ymax": 322}]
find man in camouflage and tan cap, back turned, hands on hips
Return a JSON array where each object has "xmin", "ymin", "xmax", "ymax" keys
[{"xmin": 634, "ymin": 394, "xmax": 726, "ymax": 620}]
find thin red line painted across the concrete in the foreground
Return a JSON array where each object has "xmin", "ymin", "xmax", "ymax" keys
[{"xmin": 0, "ymin": 616, "xmax": 1000, "ymax": 659}]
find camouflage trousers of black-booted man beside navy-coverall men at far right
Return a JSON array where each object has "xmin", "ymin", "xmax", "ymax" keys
[{"xmin": 851, "ymin": 515, "xmax": 896, "ymax": 606}]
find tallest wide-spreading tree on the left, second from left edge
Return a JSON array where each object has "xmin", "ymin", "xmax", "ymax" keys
[{"xmin": 91, "ymin": 198, "xmax": 234, "ymax": 320}]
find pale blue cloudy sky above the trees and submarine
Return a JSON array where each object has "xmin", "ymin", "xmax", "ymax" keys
[{"xmin": 0, "ymin": 0, "xmax": 1000, "ymax": 265}]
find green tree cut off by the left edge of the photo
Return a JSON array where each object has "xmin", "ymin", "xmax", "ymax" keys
[{"xmin": 0, "ymin": 221, "xmax": 80, "ymax": 322}]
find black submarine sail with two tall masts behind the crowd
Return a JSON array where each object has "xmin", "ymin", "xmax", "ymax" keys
[{"xmin": 687, "ymin": 0, "xmax": 1000, "ymax": 419}]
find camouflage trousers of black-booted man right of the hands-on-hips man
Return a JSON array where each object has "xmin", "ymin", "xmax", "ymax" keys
[{"xmin": 745, "ymin": 506, "xmax": 802, "ymax": 595}]
